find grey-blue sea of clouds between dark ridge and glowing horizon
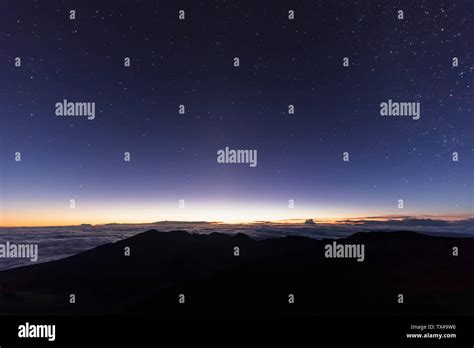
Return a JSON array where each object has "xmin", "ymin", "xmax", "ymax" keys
[{"xmin": 0, "ymin": 217, "xmax": 474, "ymax": 270}]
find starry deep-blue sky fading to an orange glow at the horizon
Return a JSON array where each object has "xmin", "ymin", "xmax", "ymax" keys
[{"xmin": 0, "ymin": 0, "xmax": 474, "ymax": 226}]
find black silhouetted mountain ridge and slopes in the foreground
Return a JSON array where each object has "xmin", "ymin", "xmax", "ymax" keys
[{"xmin": 0, "ymin": 230, "xmax": 474, "ymax": 319}]
